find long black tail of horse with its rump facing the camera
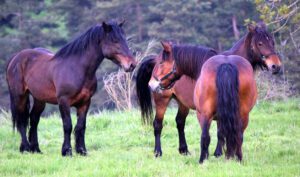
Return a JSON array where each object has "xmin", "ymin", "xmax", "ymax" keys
[{"xmin": 216, "ymin": 63, "xmax": 241, "ymax": 158}]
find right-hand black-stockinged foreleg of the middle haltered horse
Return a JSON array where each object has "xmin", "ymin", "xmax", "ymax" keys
[{"xmin": 176, "ymin": 103, "xmax": 190, "ymax": 155}]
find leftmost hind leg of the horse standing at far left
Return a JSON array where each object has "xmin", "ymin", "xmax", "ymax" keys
[{"xmin": 10, "ymin": 93, "xmax": 30, "ymax": 153}]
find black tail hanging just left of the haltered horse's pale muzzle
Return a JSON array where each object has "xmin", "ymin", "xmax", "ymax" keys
[{"xmin": 136, "ymin": 56, "xmax": 155, "ymax": 124}]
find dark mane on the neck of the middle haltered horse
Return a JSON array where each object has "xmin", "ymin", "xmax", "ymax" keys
[{"xmin": 163, "ymin": 45, "xmax": 217, "ymax": 79}]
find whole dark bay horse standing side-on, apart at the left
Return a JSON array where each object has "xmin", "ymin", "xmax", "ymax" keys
[{"xmin": 6, "ymin": 21, "xmax": 136, "ymax": 156}]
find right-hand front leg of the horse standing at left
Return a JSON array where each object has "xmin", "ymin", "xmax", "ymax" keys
[{"xmin": 75, "ymin": 100, "xmax": 91, "ymax": 155}]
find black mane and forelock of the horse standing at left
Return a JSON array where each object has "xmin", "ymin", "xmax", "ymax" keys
[{"xmin": 54, "ymin": 21, "xmax": 122, "ymax": 58}]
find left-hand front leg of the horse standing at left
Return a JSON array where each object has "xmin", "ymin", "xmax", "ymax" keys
[{"xmin": 58, "ymin": 98, "xmax": 72, "ymax": 156}]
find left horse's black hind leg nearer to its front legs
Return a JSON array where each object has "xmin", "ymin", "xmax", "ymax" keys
[{"xmin": 29, "ymin": 99, "xmax": 46, "ymax": 153}]
